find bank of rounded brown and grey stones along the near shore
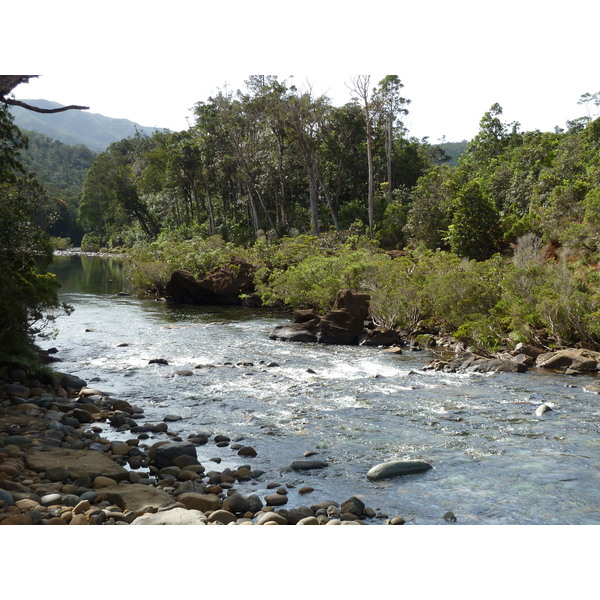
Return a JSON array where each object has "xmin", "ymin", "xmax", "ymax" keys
[{"xmin": 0, "ymin": 360, "xmax": 412, "ymax": 525}]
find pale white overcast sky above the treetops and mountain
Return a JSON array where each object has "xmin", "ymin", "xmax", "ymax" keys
[{"xmin": 5, "ymin": 0, "xmax": 600, "ymax": 142}]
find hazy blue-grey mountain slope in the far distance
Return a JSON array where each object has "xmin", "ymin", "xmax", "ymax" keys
[{"xmin": 10, "ymin": 100, "xmax": 164, "ymax": 152}]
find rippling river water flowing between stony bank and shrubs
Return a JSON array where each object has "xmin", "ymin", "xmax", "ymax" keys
[{"xmin": 45, "ymin": 256, "xmax": 600, "ymax": 525}]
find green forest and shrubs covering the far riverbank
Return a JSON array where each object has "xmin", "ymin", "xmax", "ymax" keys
[{"xmin": 2, "ymin": 75, "xmax": 600, "ymax": 366}]
